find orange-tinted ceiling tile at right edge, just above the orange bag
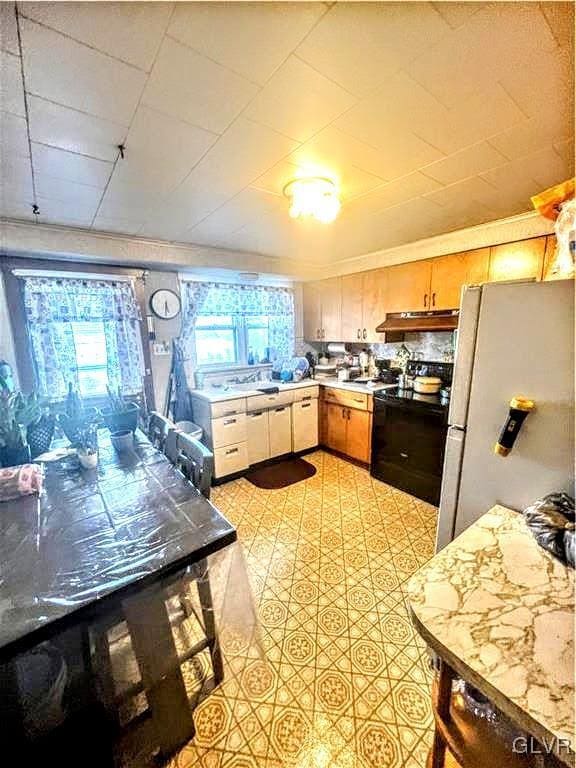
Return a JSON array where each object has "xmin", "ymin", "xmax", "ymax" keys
[{"xmin": 489, "ymin": 112, "xmax": 573, "ymax": 160}]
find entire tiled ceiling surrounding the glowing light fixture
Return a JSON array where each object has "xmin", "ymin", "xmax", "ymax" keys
[{"xmin": 0, "ymin": 2, "xmax": 574, "ymax": 264}]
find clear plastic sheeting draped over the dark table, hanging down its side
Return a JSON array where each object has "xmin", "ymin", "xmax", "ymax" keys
[{"xmin": 0, "ymin": 434, "xmax": 263, "ymax": 765}]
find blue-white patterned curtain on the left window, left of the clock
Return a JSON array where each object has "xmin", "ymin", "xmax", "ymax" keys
[{"xmin": 24, "ymin": 277, "xmax": 144, "ymax": 399}]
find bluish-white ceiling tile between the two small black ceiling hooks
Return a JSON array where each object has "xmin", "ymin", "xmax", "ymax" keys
[{"xmin": 32, "ymin": 142, "xmax": 112, "ymax": 189}]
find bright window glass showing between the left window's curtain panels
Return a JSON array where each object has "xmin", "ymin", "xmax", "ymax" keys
[{"xmin": 71, "ymin": 322, "xmax": 110, "ymax": 397}]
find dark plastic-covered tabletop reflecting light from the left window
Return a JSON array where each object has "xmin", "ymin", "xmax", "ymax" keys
[{"xmin": 0, "ymin": 431, "xmax": 236, "ymax": 659}]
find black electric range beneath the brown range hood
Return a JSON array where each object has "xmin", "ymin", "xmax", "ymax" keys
[{"xmin": 370, "ymin": 361, "xmax": 452, "ymax": 505}]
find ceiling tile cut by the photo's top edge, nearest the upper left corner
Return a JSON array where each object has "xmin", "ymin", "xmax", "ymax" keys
[{"xmin": 21, "ymin": 2, "xmax": 172, "ymax": 72}]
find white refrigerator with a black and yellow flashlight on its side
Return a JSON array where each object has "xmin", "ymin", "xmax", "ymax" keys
[{"xmin": 436, "ymin": 280, "xmax": 574, "ymax": 551}]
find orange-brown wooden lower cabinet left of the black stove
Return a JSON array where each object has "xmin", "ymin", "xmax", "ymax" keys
[{"xmin": 320, "ymin": 401, "xmax": 372, "ymax": 464}]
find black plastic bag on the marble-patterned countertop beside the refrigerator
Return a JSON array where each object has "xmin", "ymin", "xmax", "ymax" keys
[{"xmin": 524, "ymin": 493, "xmax": 576, "ymax": 568}]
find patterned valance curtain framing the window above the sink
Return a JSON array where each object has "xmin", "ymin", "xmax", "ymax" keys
[{"xmin": 182, "ymin": 281, "xmax": 294, "ymax": 359}]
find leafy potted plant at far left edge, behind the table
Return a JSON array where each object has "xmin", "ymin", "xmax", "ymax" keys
[{"xmin": 0, "ymin": 389, "xmax": 41, "ymax": 467}]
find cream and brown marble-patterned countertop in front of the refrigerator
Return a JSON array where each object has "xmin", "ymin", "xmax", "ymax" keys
[{"xmin": 409, "ymin": 506, "xmax": 575, "ymax": 762}]
